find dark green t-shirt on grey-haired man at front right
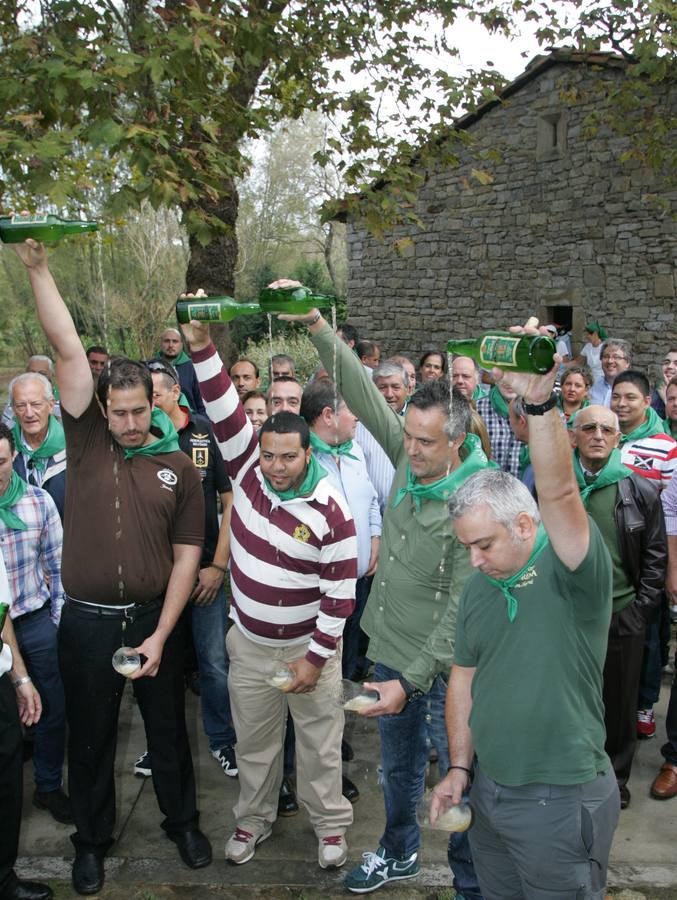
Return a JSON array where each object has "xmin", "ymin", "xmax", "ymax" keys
[{"xmin": 454, "ymin": 517, "xmax": 611, "ymax": 786}]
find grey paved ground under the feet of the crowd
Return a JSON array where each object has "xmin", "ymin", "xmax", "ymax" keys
[{"xmin": 14, "ymin": 664, "xmax": 677, "ymax": 900}]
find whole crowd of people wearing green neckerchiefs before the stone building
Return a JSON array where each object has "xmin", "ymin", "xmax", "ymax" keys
[{"xmin": 0, "ymin": 241, "xmax": 677, "ymax": 900}]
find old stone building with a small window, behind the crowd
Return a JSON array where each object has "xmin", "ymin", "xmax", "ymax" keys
[{"xmin": 347, "ymin": 50, "xmax": 677, "ymax": 374}]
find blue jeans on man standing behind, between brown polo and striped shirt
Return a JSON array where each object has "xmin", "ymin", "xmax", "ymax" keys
[{"xmin": 191, "ymin": 588, "xmax": 236, "ymax": 750}]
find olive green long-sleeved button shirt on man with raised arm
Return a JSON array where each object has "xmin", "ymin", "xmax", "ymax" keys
[{"xmin": 312, "ymin": 325, "xmax": 472, "ymax": 691}]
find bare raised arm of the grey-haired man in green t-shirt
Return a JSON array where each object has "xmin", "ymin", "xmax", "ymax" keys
[{"xmin": 492, "ymin": 328, "xmax": 590, "ymax": 571}]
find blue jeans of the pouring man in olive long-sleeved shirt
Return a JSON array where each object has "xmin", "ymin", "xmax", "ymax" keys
[{"xmin": 374, "ymin": 663, "xmax": 482, "ymax": 900}]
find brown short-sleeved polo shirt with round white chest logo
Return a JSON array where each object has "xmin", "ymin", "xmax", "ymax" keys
[{"xmin": 61, "ymin": 397, "xmax": 204, "ymax": 605}]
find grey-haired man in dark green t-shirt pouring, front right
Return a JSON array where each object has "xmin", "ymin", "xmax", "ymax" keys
[{"xmin": 431, "ymin": 340, "xmax": 620, "ymax": 900}]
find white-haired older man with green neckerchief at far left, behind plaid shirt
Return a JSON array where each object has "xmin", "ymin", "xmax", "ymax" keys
[{"xmin": 9, "ymin": 372, "xmax": 66, "ymax": 521}]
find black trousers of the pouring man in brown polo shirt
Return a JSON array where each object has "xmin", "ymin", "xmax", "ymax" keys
[{"xmin": 59, "ymin": 601, "xmax": 198, "ymax": 854}]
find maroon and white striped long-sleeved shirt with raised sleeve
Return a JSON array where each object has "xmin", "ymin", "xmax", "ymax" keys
[{"xmin": 192, "ymin": 344, "xmax": 357, "ymax": 666}]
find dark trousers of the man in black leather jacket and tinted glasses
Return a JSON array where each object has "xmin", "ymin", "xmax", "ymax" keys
[{"xmin": 602, "ymin": 603, "xmax": 645, "ymax": 787}]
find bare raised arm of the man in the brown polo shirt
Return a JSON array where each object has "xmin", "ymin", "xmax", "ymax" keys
[{"xmin": 12, "ymin": 240, "xmax": 94, "ymax": 419}]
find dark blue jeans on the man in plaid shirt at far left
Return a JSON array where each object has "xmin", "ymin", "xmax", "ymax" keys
[{"xmin": 12, "ymin": 606, "xmax": 66, "ymax": 793}]
